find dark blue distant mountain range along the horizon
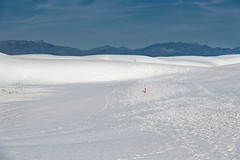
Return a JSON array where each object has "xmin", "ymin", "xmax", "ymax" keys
[{"xmin": 0, "ymin": 40, "xmax": 240, "ymax": 57}]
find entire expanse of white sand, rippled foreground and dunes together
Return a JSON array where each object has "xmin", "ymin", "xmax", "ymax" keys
[{"xmin": 0, "ymin": 54, "xmax": 240, "ymax": 160}]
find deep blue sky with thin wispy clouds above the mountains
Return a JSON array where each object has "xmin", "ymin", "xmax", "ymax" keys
[{"xmin": 0, "ymin": 0, "xmax": 240, "ymax": 49}]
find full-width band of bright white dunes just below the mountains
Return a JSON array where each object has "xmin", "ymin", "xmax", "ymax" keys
[{"xmin": 0, "ymin": 53, "xmax": 240, "ymax": 84}]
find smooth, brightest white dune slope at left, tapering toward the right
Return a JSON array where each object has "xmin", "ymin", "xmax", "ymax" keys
[{"xmin": 0, "ymin": 54, "xmax": 187, "ymax": 84}]
